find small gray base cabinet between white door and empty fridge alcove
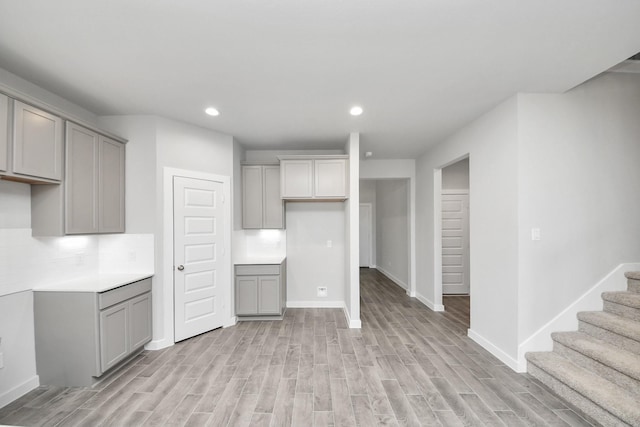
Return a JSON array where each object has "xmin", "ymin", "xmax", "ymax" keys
[{"xmin": 235, "ymin": 261, "xmax": 287, "ymax": 320}]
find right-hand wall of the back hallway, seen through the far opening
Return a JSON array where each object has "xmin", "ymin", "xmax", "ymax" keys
[{"xmin": 376, "ymin": 179, "xmax": 409, "ymax": 289}]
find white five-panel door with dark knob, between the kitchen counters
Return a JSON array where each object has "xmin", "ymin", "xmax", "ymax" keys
[{"xmin": 173, "ymin": 176, "xmax": 230, "ymax": 342}]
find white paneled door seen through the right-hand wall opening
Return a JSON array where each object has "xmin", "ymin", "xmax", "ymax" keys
[{"xmin": 442, "ymin": 194, "xmax": 469, "ymax": 294}]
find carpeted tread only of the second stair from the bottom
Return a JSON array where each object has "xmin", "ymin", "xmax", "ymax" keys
[{"xmin": 551, "ymin": 332, "xmax": 640, "ymax": 381}]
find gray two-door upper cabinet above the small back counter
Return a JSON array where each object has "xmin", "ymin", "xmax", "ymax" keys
[{"xmin": 242, "ymin": 165, "xmax": 284, "ymax": 229}]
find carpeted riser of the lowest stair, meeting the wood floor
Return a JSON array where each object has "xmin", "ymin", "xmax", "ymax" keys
[{"xmin": 527, "ymin": 362, "xmax": 629, "ymax": 427}]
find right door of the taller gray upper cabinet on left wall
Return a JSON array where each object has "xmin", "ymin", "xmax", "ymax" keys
[{"xmin": 98, "ymin": 136, "xmax": 125, "ymax": 233}]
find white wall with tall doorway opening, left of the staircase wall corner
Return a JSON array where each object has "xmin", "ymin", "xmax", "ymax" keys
[{"xmin": 416, "ymin": 97, "xmax": 518, "ymax": 366}]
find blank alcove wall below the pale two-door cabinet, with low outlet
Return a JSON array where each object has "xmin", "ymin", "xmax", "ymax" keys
[{"xmin": 286, "ymin": 202, "xmax": 345, "ymax": 307}]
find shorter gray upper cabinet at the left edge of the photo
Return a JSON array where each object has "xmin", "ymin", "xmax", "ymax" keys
[{"xmin": 0, "ymin": 94, "xmax": 63, "ymax": 184}]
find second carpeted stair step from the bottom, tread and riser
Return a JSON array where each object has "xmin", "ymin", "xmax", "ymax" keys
[{"xmin": 551, "ymin": 332, "xmax": 640, "ymax": 395}]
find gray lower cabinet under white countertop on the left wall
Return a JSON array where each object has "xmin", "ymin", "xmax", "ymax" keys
[{"xmin": 34, "ymin": 278, "xmax": 151, "ymax": 387}]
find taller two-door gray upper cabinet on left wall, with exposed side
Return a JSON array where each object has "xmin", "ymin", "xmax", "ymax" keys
[{"xmin": 31, "ymin": 122, "xmax": 125, "ymax": 236}]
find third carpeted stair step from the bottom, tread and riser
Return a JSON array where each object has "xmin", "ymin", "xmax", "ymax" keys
[{"xmin": 578, "ymin": 311, "xmax": 640, "ymax": 354}]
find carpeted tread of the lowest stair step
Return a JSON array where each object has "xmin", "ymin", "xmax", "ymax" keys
[{"xmin": 526, "ymin": 352, "xmax": 640, "ymax": 426}]
